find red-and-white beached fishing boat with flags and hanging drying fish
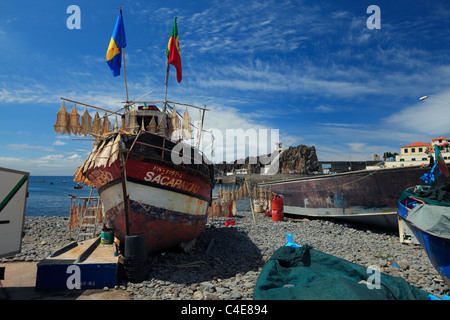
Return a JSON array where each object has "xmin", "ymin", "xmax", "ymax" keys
[{"xmin": 55, "ymin": 11, "xmax": 214, "ymax": 253}]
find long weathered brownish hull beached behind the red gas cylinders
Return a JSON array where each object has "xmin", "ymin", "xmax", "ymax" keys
[{"xmin": 259, "ymin": 167, "xmax": 438, "ymax": 230}]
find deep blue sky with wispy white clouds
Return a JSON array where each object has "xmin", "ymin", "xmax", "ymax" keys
[{"xmin": 0, "ymin": 0, "xmax": 450, "ymax": 175}]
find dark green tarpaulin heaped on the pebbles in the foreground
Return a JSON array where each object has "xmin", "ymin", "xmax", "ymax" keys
[{"xmin": 253, "ymin": 245, "xmax": 429, "ymax": 300}]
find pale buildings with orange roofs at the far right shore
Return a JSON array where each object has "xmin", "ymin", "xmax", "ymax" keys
[{"xmin": 384, "ymin": 137, "xmax": 450, "ymax": 168}]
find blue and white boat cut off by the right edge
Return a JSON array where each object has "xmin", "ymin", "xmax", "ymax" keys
[{"xmin": 398, "ymin": 185, "xmax": 450, "ymax": 286}]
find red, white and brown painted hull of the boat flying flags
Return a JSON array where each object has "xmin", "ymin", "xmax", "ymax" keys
[{"xmin": 79, "ymin": 131, "xmax": 213, "ymax": 253}]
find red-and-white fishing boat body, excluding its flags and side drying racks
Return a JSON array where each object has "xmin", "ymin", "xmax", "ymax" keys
[{"xmin": 75, "ymin": 106, "xmax": 214, "ymax": 253}]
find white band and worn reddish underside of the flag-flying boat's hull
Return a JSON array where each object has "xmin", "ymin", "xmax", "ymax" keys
[{"xmin": 100, "ymin": 182, "xmax": 208, "ymax": 253}]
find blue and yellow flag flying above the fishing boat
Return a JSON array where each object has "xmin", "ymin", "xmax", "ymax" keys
[{"xmin": 106, "ymin": 9, "xmax": 127, "ymax": 77}]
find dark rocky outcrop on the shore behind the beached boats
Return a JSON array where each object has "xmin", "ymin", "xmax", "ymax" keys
[{"xmin": 214, "ymin": 145, "xmax": 319, "ymax": 176}]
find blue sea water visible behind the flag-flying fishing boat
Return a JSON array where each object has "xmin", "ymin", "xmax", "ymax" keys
[{"xmin": 25, "ymin": 176, "xmax": 250, "ymax": 217}]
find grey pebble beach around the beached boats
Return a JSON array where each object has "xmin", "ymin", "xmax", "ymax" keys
[{"xmin": 0, "ymin": 212, "xmax": 450, "ymax": 300}]
